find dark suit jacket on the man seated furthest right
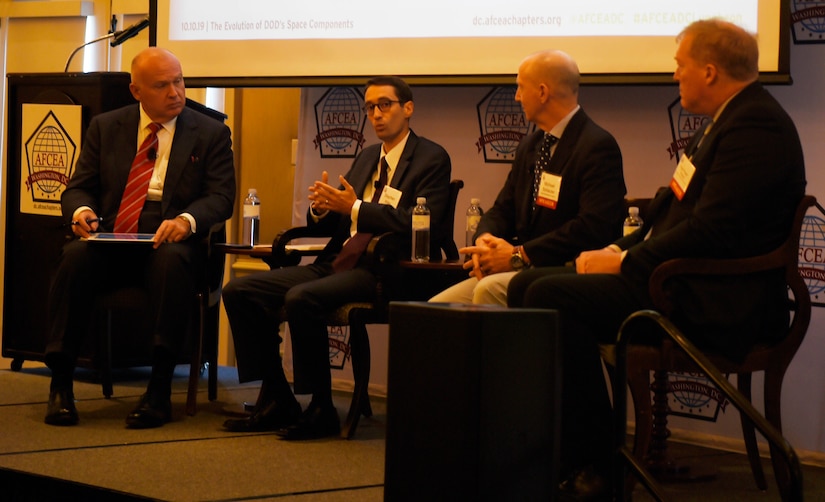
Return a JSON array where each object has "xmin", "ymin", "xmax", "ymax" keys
[{"xmin": 616, "ymin": 83, "xmax": 806, "ymax": 357}]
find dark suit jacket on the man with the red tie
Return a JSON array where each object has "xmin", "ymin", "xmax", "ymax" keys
[{"xmin": 61, "ymin": 103, "xmax": 235, "ymax": 235}]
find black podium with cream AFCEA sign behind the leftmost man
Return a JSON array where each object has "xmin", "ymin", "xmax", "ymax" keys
[{"xmin": 3, "ymin": 72, "xmax": 135, "ymax": 369}]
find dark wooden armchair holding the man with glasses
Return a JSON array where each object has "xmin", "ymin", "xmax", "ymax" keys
[{"xmin": 264, "ymin": 180, "xmax": 466, "ymax": 439}]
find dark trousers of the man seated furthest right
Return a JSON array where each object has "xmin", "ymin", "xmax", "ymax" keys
[{"xmin": 507, "ymin": 267, "xmax": 649, "ymax": 476}]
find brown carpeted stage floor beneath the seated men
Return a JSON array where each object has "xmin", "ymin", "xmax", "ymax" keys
[{"xmin": 0, "ymin": 359, "xmax": 825, "ymax": 502}]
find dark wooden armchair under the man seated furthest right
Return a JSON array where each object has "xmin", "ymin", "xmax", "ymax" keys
[{"xmin": 602, "ymin": 196, "xmax": 816, "ymax": 497}]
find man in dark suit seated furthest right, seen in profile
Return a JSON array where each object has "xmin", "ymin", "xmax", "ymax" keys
[{"xmin": 509, "ymin": 20, "xmax": 806, "ymax": 498}]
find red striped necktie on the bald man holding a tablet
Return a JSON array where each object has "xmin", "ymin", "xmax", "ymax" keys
[{"xmin": 114, "ymin": 122, "xmax": 163, "ymax": 233}]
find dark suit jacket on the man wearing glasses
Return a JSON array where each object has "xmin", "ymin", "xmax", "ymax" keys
[{"xmin": 307, "ymin": 131, "xmax": 453, "ymax": 262}]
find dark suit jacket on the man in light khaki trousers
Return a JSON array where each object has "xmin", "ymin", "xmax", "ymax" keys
[{"xmin": 478, "ymin": 109, "xmax": 626, "ymax": 266}]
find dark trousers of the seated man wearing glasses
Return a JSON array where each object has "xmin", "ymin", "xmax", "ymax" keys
[{"xmin": 223, "ymin": 262, "xmax": 376, "ymax": 395}]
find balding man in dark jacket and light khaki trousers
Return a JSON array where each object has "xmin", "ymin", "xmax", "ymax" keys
[{"xmin": 430, "ymin": 51, "xmax": 626, "ymax": 305}]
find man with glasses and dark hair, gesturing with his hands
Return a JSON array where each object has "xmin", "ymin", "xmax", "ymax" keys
[{"xmin": 223, "ymin": 77, "xmax": 452, "ymax": 440}]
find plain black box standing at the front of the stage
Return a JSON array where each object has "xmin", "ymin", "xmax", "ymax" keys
[{"xmin": 384, "ymin": 302, "xmax": 561, "ymax": 501}]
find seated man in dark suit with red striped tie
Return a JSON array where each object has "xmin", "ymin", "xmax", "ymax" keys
[{"xmin": 46, "ymin": 47, "xmax": 235, "ymax": 428}]
